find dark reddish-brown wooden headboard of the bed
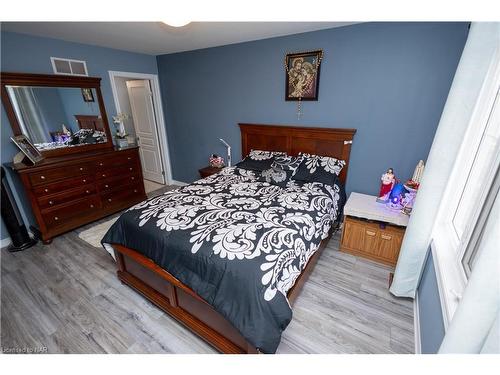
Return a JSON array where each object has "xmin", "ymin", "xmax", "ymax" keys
[{"xmin": 239, "ymin": 124, "xmax": 356, "ymax": 185}]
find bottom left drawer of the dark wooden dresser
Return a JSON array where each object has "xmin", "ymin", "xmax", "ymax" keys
[{"xmin": 42, "ymin": 194, "xmax": 102, "ymax": 226}]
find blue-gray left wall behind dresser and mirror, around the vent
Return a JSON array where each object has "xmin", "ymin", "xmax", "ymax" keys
[{"xmin": 0, "ymin": 31, "xmax": 158, "ymax": 239}]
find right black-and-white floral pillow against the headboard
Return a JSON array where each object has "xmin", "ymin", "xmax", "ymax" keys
[{"xmin": 293, "ymin": 153, "xmax": 345, "ymax": 185}]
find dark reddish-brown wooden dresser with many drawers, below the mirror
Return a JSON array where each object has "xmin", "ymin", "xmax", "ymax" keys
[{"xmin": 11, "ymin": 147, "xmax": 146, "ymax": 244}]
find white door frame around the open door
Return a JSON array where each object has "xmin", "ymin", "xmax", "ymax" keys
[{"xmin": 108, "ymin": 70, "xmax": 173, "ymax": 185}]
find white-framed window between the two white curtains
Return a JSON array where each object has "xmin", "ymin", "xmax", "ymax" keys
[{"xmin": 431, "ymin": 50, "xmax": 500, "ymax": 326}]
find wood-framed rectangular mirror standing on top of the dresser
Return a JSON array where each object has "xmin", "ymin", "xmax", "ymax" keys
[{"xmin": 1, "ymin": 73, "xmax": 112, "ymax": 157}]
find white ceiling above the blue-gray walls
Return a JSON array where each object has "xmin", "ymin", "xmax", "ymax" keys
[{"xmin": 1, "ymin": 22, "xmax": 354, "ymax": 55}]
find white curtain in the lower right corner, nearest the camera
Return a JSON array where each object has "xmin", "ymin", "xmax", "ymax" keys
[{"xmin": 439, "ymin": 189, "xmax": 500, "ymax": 353}]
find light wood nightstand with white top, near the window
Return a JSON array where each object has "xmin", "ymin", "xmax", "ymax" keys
[{"xmin": 340, "ymin": 193, "xmax": 409, "ymax": 266}]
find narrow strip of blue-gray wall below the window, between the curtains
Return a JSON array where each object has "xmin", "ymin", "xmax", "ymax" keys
[{"xmin": 415, "ymin": 253, "xmax": 445, "ymax": 354}]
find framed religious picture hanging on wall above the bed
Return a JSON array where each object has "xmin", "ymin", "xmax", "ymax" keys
[{"xmin": 285, "ymin": 50, "xmax": 323, "ymax": 100}]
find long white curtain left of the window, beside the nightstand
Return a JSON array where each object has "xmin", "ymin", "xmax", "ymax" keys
[{"xmin": 390, "ymin": 22, "xmax": 500, "ymax": 298}]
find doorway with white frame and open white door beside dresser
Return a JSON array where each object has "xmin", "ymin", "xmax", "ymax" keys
[{"xmin": 109, "ymin": 71, "xmax": 172, "ymax": 193}]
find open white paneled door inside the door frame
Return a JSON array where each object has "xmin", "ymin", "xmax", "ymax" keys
[{"xmin": 127, "ymin": 80, "xmax": 165, "ymax": 184}]
